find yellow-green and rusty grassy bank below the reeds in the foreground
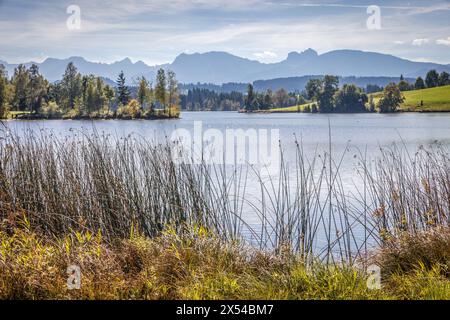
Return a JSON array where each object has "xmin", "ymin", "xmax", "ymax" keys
[{"xmin": 0, "ymin": 222, "xmax": 450, "ymax": 299}]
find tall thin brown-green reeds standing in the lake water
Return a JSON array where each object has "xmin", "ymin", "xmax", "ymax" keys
[{"xmin": 0, "ymin": 127, "xmax": 450, "ymax": 264}]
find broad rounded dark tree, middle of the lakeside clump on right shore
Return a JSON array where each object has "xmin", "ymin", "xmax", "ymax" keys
[{"xmin": 334, "ymin": 84, "xmax": 368, "ymax": 112}]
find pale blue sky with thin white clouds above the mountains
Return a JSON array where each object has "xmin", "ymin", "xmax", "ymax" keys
[{"xmin": 0, "ymin": 0, "xmax": 450, "ymax": 65}]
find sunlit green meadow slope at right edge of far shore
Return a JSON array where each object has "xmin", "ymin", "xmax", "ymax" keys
[{"xmin": 372, "ymin": 86, "xmax": 450, "ymax": 112}]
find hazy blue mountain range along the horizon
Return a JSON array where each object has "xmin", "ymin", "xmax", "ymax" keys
[{"xmin": 0, "ymin": 49, "xmax": 450, "ymax": 84}]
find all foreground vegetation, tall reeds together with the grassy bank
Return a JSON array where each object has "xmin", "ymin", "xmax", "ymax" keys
[{"xmin": 0, "ymin": 131, "xmax": 450, "ymax": 299}]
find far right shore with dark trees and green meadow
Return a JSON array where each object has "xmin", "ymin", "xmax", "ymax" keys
[{"xmin": 250, "ymin": 70, "xmax": 450, "ymax": 113}]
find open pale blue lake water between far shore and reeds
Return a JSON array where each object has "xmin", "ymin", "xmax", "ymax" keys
[{"xmin": 3, "ymin": 112, "xmax": 450, "ymax": 252}]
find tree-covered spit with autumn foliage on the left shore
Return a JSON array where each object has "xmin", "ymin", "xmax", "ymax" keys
[{"xmin": 0, "ymin": 62, "xmax": 180, "ymax": 119}]
